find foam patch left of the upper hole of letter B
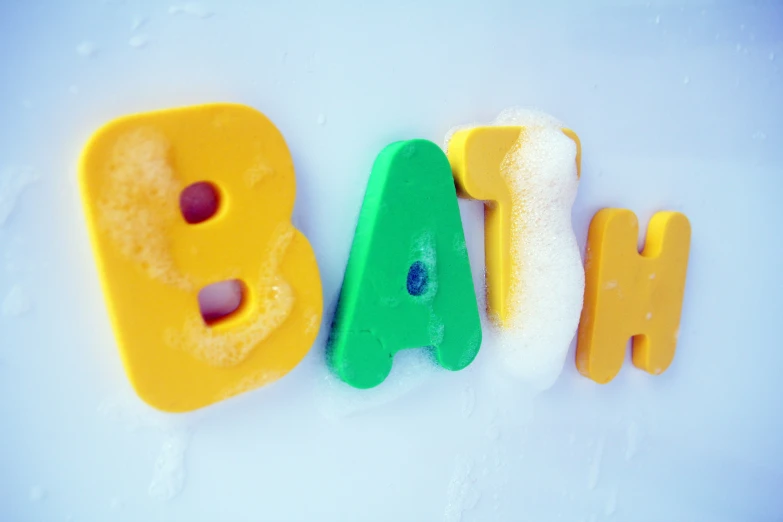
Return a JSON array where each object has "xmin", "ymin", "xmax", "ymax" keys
[{"xmin": 98, "ymin": 128, "xmax": 194, "ymax": 290}]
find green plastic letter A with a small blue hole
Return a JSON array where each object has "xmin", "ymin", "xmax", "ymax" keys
[{"xmin": 328, "ymin": 140, "xmax": 481, "ymax": 388}]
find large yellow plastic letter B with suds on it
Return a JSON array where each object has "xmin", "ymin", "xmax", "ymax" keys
[{"xmin": 80, "ymin": 104, "xmax": 322, "ymax": 412}]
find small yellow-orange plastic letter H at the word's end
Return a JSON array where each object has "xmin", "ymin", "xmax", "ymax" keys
[{"xmin": 576, "ymin": 209, "xmax": 691, "ymax": 384}]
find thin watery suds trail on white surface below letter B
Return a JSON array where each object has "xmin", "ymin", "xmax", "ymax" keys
[{"xmin": 98, "ymin": 390, "xmax": 194, "ymax": 501}]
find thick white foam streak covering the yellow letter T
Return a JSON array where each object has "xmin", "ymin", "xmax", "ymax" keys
[{"xmin": 447, "ymin": 108, "xmax": 584, "ymax": 391}]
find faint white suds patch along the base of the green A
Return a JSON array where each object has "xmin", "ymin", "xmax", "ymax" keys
[{"xmin": 314, "ymin": 349, "xmax": 442, "ymax": 419}]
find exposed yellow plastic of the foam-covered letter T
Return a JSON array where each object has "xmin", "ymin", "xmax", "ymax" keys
[{"xmin": 448, "ymin": 126, "xmax": 582, "ymax": 327}]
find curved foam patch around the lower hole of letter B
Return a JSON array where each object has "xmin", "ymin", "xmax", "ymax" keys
[{"xmin": 166, "ymin": 223, "xmax": 296, "ymax": 367}]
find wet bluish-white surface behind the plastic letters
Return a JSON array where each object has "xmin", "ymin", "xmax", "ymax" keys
[{"xmin": 0, "ymin": 0, "xmax": 783, "ymax": 522}]
